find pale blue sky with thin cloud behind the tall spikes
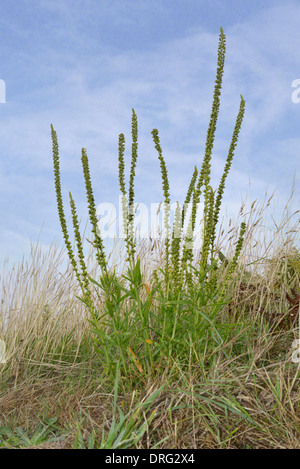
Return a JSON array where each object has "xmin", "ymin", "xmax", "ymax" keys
[{"xmin": 0, "ymin": 0, "xmax": 300, "ymax": 278}]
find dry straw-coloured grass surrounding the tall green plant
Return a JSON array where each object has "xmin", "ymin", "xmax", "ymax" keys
[{"xmin": 0, "ymin": 186, "xmax": 300, "ymax": 449}]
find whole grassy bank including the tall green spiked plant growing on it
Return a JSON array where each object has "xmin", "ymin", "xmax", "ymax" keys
[{"xmin": 0, "ymin": 29, "xmax": 300, "ymax": 449}]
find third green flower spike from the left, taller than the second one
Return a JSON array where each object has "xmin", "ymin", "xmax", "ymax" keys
[{"xmin": 81, "ymin": 148, "xmax": 107, "ymax": 272}]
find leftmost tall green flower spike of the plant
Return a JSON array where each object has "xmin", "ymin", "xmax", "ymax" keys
[{"xmin": 51, "ymin": 124, "xmax": 82, "ymax": 285}]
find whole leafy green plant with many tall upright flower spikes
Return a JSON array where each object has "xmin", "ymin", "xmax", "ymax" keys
[{"xmin": 51, "ymin": 28, "xmax": 246, "ymax": 375}]
